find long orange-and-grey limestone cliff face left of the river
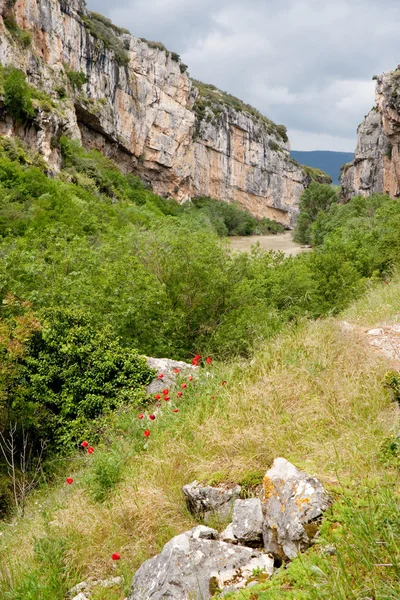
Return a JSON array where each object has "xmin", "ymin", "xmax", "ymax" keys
[{"xmin": 0, "ymin": 0, "xmax": 307, "ymax": 226}]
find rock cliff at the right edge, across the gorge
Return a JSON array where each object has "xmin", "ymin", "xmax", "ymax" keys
[{"xmin": 341, "ymin": 68, "xmax": 400, "ymax": 200}]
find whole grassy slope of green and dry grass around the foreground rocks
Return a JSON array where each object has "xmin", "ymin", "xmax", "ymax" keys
[{"xmin": 0, "ymin": 277, "xmax": 400, "ymax": 600}]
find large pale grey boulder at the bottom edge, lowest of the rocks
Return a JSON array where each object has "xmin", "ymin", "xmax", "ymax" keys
[{"xmin": 128, "ymin": 528, "xmax": 274, "ymax": 600}]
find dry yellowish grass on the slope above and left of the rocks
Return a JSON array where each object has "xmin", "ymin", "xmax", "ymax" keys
[{"xmin": 0, "ymin": 282, "xmax": 400, "ymax": 598}]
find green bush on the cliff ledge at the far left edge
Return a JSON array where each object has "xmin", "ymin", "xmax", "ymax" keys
[{"xmin": 4, "ymin": 69, "xmax": 35, "ymax": 123}]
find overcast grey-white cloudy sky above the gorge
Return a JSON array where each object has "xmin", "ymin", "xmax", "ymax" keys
[{"xmin": 87, "ymin": 0, "xmax": 400, "ymax": 152}]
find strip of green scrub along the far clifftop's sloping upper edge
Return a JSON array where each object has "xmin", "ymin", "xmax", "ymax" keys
[{"xmin": 192, "ymin": 79, "xmax": 288, "ymax": 142}]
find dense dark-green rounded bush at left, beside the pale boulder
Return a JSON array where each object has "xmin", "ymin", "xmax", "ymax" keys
[{"xmin": 0, "ymin": 302, "xmax": 151, "ymax": 453}]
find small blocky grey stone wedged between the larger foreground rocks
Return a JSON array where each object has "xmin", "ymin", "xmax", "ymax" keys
[{"xmin": 232, "ymin": 498, "xmax": 264, "ymax": 546}]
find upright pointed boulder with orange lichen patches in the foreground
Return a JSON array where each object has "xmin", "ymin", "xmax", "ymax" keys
[{"xmin": 261, "ymin": 458, "xmax": 331, "ymax": 560}]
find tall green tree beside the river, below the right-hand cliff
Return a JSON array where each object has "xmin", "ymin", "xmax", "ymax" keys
[{"xmin": 293, "ymin": 185, "xmax": 339, "ymax": 244}]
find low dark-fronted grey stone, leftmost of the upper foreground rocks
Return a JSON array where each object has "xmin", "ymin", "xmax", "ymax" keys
[{"xmin": 182, "ymin": 481, "xmax": 241, "ymax": 522}]
